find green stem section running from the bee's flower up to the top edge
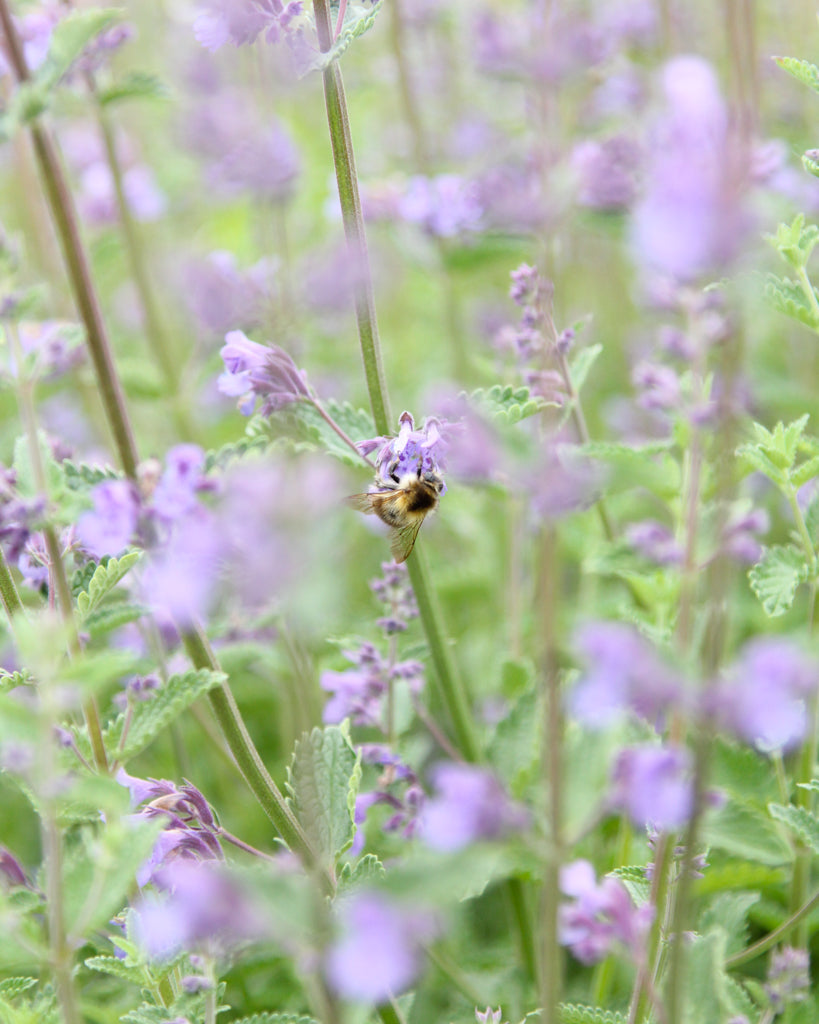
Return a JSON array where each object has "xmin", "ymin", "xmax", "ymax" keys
[{"xmin": 313, "ymin": 0, "xmax": 392, "ymax": 434}]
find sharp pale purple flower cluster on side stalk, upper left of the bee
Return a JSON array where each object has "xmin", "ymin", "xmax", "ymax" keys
[{"xmin": 218, "ymin": 331, "xmax": 310, "ymax": 416}]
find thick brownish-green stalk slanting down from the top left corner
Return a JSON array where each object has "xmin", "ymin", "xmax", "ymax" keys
[{"xmin": 0, "ymin": 0, "xmax": 138, "ymax": 479}]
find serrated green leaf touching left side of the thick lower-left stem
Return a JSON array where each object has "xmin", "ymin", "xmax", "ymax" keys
[{"xmin": 104, "ymin": 669, "xmax": 227, "ymax": 761}]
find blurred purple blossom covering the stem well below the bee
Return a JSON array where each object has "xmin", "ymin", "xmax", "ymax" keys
[{"xmin": 421, "ymin": 763, "xmax": 528, "ymax": 851}]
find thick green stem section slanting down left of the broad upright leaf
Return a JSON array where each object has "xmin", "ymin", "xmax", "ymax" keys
[{"xmin": 182, "ymin": 629, "xmax": 336, "ymax": 894}]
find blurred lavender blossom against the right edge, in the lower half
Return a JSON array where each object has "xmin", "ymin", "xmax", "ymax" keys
[{"xmin": 705, "ymin": 637, "xmax": 819, "ymax": 751}]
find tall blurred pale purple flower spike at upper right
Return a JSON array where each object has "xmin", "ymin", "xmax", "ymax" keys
[{"xmin": 632, "ymin": 56, "xmax": 749, "ymax": 281}]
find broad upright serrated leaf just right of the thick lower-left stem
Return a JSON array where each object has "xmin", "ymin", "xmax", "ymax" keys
[{"xmin": 287, "ymin": 725, "xmax": 361, "ymax": 864}]
